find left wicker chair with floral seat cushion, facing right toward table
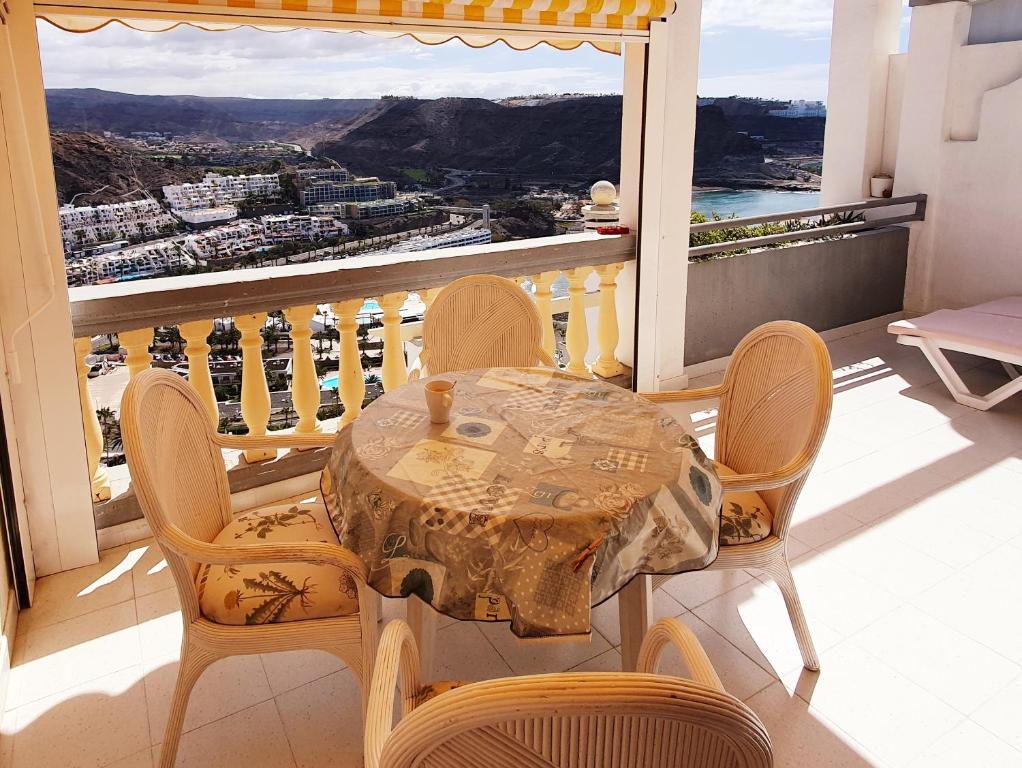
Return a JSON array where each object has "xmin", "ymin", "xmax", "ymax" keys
[{"xmin": 121, "ymin": 369, "xmax": 377, "ymax": 768}]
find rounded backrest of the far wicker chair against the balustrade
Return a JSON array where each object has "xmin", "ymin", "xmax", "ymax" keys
[{"xmin": 410, "ymin": 275, "xmax": 554, "ymax": 379}]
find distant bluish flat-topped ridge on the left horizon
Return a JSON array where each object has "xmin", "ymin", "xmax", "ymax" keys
[{"xmin": 46, "ymin": 88, "xmax": 377, "ymax": 141}]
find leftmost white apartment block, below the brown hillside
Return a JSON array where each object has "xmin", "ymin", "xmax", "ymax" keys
[{"xmin": 59, "ymin": 198, "xmax": 177, "ymax": 251}]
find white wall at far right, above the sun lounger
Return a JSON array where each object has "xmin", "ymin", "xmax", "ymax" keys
[{"xmin": 894, "ymin": 2, "xmax": 1022, "ymax": 312}]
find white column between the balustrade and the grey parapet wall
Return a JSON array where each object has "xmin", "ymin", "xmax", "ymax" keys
[{"xmin": 621, "ymin": 0, "xmax": 702, "ymax": 392}]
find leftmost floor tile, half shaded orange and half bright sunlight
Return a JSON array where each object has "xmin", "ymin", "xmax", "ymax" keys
[{"xmin": 7, "ymin": 600, "xmax": 142, "ymax": 709}]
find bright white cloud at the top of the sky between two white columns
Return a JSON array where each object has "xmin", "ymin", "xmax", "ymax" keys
[{"xmin": 702, "ymin": 0, "xmax": 834, "ymax": 36}]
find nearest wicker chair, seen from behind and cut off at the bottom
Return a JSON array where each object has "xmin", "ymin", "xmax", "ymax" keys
[{"xmin": 365, "ymin": 619, "xmax": 773, "ymax": 768}]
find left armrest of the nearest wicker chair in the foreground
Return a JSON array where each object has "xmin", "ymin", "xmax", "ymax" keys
[{"xmin": 365, "ymin": 619, "xmax": 422, "ymax": 768}]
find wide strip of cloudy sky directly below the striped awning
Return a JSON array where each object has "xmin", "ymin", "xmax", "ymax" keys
[{"xmin": 39, "ymin": 22, "xmax": 621, "ymax": 98}]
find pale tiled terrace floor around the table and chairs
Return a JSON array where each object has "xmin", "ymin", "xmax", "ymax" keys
[{"xmin": 0, "ymin": 331, "xmax": 1022, "ymax": 768}]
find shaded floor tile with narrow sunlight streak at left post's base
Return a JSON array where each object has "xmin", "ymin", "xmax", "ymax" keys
[{"xmin": 17, "ymin": 546, "xmax": 140, "ymax": 634}]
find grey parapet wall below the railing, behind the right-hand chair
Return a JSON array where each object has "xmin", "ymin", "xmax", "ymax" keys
[{"xmin": 685, "ymin": 227, "xmax": 909, "ymax": 365}]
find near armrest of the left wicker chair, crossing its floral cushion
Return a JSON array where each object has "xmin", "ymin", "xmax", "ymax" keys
[{"xmin": 158, "ymin": 526, "xmax": 369, "ymax": 582}]
